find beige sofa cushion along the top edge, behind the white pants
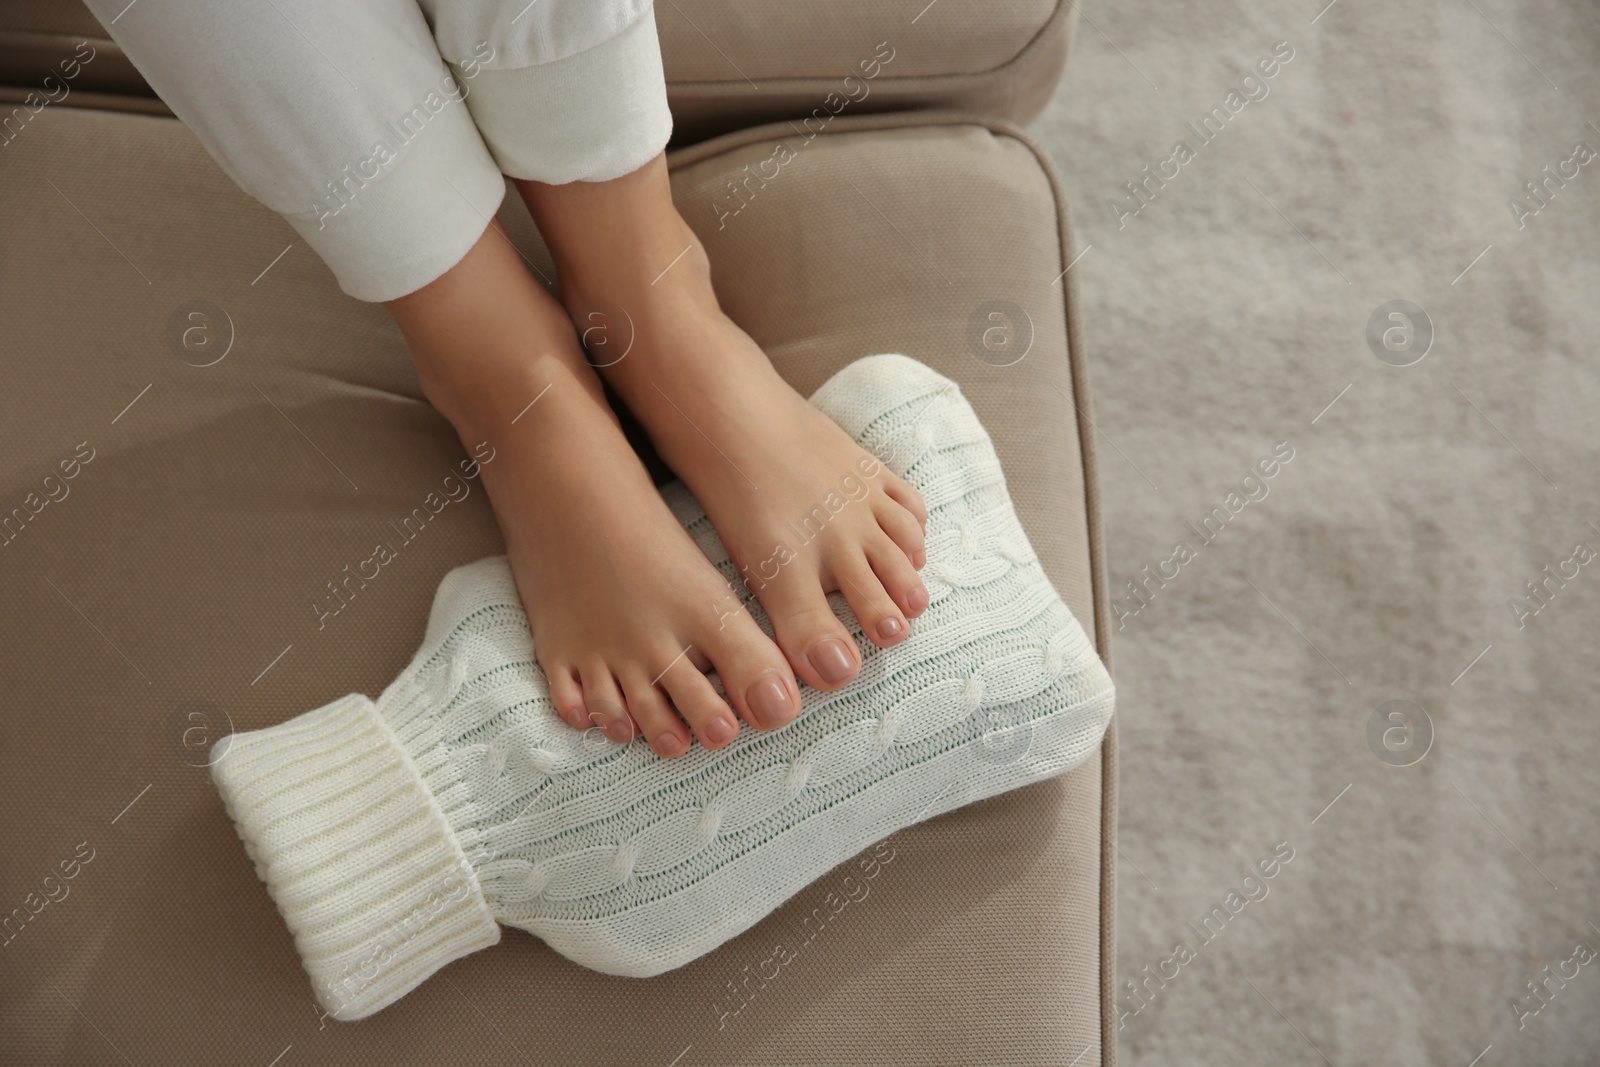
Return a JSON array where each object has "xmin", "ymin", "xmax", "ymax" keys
[{"xmin": 0, "ymin": 0, "xmax": 1077, "ymax": 137}]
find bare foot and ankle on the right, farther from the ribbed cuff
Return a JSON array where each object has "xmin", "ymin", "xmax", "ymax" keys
[{"xmin": 517, "ymin": 157, "xmax": 928, "ymax": 689}]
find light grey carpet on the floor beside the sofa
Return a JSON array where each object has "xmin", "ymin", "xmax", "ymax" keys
[{"xmin": 1032, "ymin": 0, "xmax": 1600, "ymax": 1067}]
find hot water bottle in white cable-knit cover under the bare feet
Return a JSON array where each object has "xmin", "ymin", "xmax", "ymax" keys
[{"xmin": 213, "ymin": 355, "xmax": 1112, "ymax": 1019}]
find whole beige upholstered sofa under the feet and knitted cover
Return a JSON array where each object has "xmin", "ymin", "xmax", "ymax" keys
[{"xmin": 0, "ymin": 0, "xmax": 1117, "ymax": 1067}]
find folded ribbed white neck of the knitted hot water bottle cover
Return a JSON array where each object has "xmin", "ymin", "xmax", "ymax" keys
[{"xmin": 211, "ymin": 694, "xmax": 499, "ymax": 1019}]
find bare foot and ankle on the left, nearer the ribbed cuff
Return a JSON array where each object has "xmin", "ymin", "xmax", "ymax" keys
[{"xmin": 387, "ymin": 222, "xmax": 800, "ymax": 757}]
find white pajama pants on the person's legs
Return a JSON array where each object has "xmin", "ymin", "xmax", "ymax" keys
[{"xmin": 86, "ymin": 0, "xmax": 672, "ymax": 301}]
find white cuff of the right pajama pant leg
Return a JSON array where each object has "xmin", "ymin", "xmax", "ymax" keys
[{"xmin": 456, "ymin": 11, "xmax": 672, "ymax": 186}]
